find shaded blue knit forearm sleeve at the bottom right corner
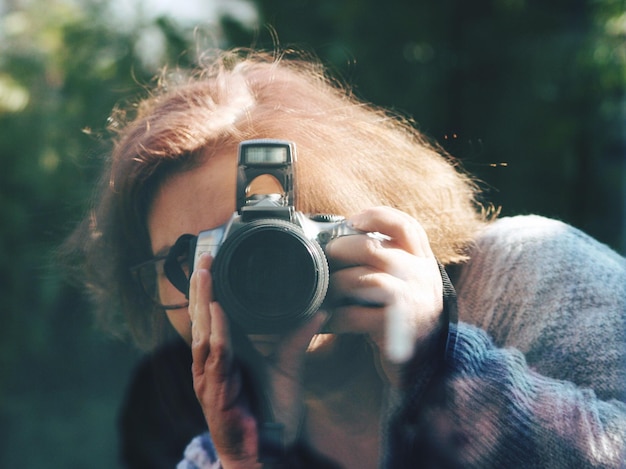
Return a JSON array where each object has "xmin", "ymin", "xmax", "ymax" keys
[{"xmin": 386, "ymin": 323, "xmax": 626, "ymax": 469}]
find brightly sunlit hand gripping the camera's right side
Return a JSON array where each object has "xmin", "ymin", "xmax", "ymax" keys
[{"xmin": 326, "ymin": 207, "xmax": 444, "ymax": 384}]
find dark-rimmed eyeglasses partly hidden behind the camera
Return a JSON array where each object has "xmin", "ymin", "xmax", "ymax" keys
[{"xmin": 130, "ymin": 250, "xmax": 189, "ymax": 309}]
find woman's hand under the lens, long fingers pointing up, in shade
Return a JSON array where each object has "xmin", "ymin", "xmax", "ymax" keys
[{"xmin": 189, "ymin": 255, "xmax": 325, "ymax": 469}]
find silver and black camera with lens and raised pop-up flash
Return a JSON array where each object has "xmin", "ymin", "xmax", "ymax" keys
[{"xmin": 191, "ymin": 139, "xmax": 361, "ymax": 334}]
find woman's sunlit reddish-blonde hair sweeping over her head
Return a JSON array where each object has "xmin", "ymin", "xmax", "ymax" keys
[{"xmin": 68, "ymin": 50, "xmax": 487, "ymax": 346}]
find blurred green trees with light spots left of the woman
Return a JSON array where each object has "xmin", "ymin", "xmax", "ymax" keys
[{"xmin": 0, "ymin": 0, "xmax": 234, "ymax": 468}]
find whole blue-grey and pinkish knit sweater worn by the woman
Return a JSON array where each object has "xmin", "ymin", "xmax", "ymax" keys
[{"xmin": 179, "ymin": 216, "xmax": 626, "ymax": 469}]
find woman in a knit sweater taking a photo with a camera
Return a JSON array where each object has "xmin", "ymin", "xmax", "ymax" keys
[{"xmin": 64, "ymin": 51, "xmax": 626, "ymax": 468}]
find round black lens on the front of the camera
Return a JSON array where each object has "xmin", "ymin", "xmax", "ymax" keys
[{"xmin": 213, "ymin": 219, "xmax": 328, "ymax": 334}]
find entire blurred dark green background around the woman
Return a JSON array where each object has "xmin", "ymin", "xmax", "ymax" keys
[{"xmin": 0, "ymin": 0, "xmax": 626, "ymax": 468}]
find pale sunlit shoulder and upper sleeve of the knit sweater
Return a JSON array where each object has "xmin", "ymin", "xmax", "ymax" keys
[{"xmin": 455, "ymin": 216, "xmax": 626, "ymax": 400}]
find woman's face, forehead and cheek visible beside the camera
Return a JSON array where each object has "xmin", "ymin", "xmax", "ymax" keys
[{"xmin": 148, "ymin": 151, "xmax": 237, "ymax": 343}]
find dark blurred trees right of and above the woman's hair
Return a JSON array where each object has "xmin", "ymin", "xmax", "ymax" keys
[{"xmin": 233, "ymin": 0, "xmax": 626, "ymax": 252}]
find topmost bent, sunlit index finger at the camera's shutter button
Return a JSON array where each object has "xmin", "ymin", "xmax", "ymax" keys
[{"xmin": 348, "ymin": 207, "xmax": 432, "ymax": 257}]
